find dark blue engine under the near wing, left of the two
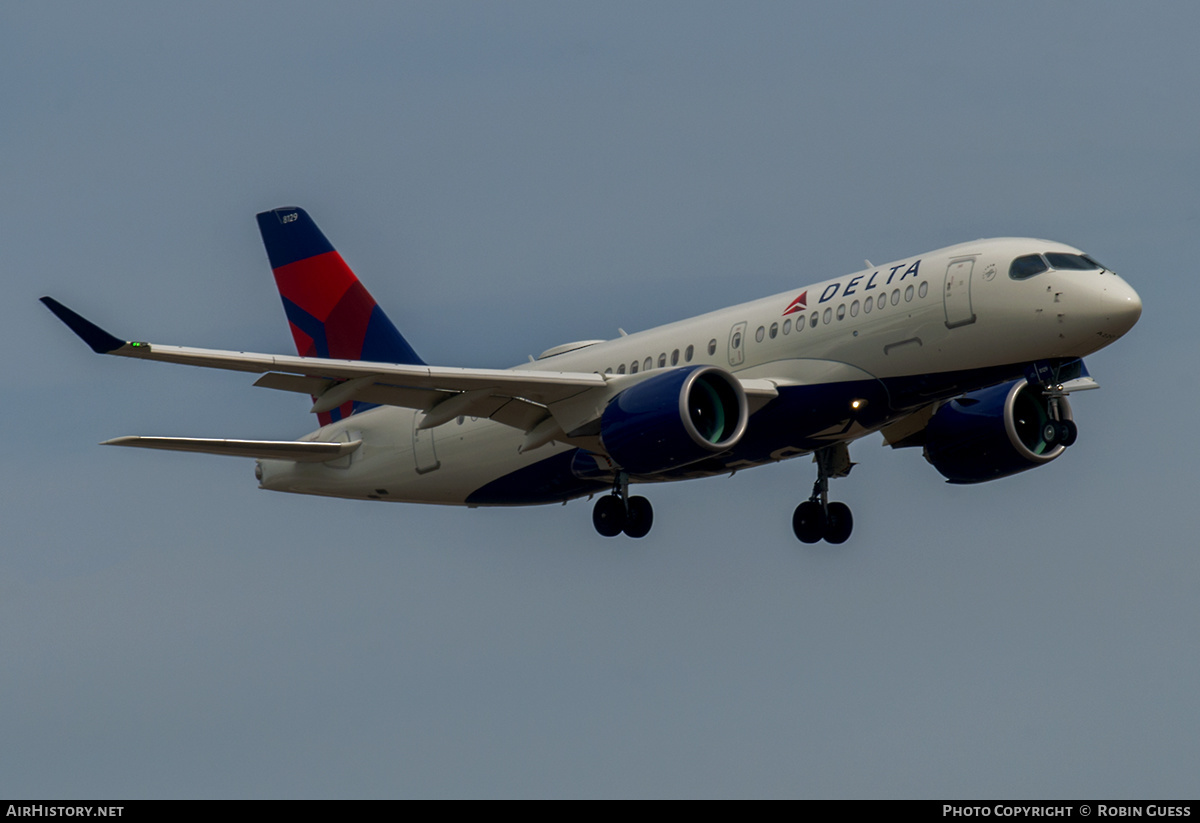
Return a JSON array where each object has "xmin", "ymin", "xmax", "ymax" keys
[{"xmin": 600, "ymin": 366, "xmax": 749, "ymax": 474}]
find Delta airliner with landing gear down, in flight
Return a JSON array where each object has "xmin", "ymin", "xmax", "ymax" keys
[{"xmin": 42, "ymin": 206, "xmax": 1141, "ymax": 543}]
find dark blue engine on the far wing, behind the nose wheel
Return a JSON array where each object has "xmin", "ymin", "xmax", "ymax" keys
[{"xmin": 925, "ymin": 379, "xmax": 1072, "ymax": 483}]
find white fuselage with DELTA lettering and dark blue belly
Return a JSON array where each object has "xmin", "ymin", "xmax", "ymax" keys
[{"xmin": 259, "ymin": 239, "xmax": 1141, "ymax": 505}]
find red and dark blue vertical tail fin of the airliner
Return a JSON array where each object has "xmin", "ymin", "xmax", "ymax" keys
[{"xmin": 258, "ymin": 208, "xmax": 425, "ymax": 425}]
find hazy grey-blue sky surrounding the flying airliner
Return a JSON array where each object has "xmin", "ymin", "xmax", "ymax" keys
[{"xmin": 0, "ymin": 2, "xmax": 1200, "ymax": 798}]
